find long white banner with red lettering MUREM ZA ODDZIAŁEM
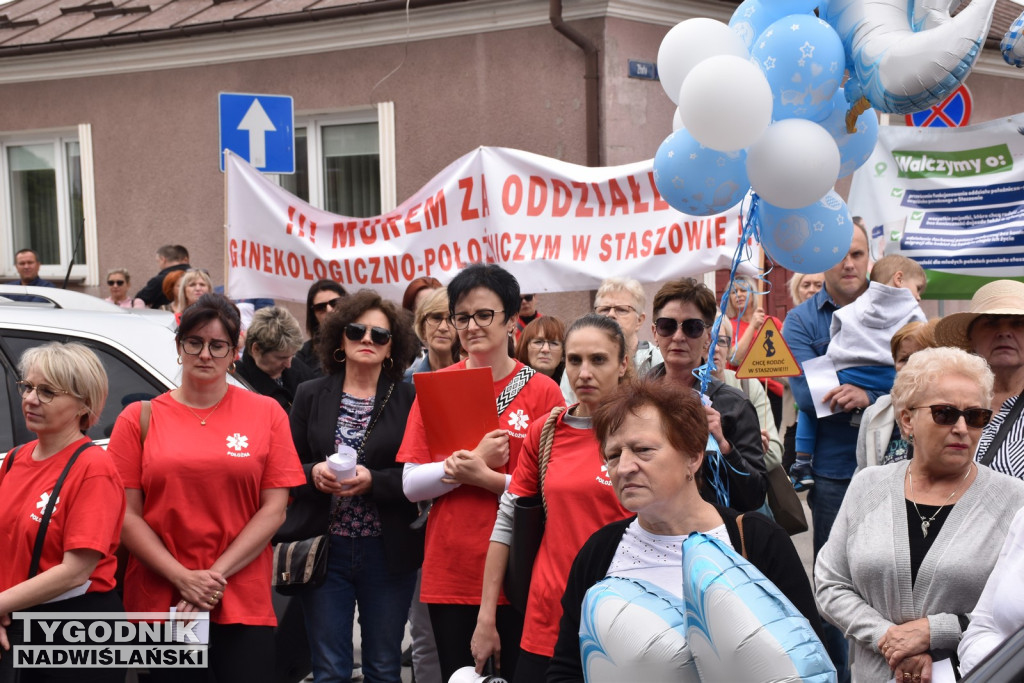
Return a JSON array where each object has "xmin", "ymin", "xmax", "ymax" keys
[{"xmin": 225, "ymin": 147, "xmax": 742, "ymax": 301}]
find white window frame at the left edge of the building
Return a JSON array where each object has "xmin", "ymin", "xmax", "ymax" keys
[{"xmin": 0, "ymin": 124, "xmax": 99, "ymax": 285}]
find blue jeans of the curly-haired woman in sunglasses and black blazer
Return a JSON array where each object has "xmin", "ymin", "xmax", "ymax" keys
[{"xmin": 300, "ymin": 536, "xmax": 416, "ymax": 683}]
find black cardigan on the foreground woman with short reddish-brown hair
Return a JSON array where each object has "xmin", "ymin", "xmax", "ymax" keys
[{"xmin": 548, "ymin": 507, "xmax": 821, "ymax": 683}]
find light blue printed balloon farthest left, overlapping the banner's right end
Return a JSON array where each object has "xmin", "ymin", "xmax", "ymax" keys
[{"xmin": 654, "ymin": 128, "xmax": 751, "ymax": 216}]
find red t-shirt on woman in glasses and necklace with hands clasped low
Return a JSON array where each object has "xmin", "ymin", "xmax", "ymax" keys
[{"xmin": 108, "ymin": 387, "xmax": 306, "ymax": 626}]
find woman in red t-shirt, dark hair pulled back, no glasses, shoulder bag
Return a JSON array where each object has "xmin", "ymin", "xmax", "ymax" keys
[{"xmin": 472, "ymin": 313, "xmax": 629, "ymax": 683}]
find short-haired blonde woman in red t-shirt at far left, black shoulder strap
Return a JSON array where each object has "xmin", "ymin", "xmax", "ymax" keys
[{"xmin": 0, "ymin": 343, "xmax": 125, "ymax": 682}]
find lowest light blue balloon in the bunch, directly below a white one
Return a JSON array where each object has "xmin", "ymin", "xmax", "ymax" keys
[{"xmin": 755, "ymin": 190, "xmax": 853, "ymax": 272}]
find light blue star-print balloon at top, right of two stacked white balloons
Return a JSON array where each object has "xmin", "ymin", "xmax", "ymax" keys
[{"xmin": 751, "ymin": 14, "xmax": 846, "ymax": 121}]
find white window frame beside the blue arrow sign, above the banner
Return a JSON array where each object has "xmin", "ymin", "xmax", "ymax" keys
[{"xmin": 268, "ymin": 101, "xmax": 397, "ymax": 213}]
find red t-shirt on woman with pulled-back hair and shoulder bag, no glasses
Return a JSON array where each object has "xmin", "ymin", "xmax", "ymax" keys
[{"xmin": 509, "ymin": 413, "xmax": 632, "ymax": 656}]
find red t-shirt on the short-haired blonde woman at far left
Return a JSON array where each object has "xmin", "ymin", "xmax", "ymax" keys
[{"xmin": 0, "ymin": 437, "xmax": 125, "ymax": 593}]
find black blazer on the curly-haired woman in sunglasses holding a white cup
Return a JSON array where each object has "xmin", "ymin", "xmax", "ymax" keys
[{"xmin": 278, "ymin": 369, "xmax": 423, "ymax": 573}]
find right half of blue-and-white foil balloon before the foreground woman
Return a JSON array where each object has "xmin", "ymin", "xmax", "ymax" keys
[{"xmin": 683, "ymin": 533, "xmax": 837, "ymax": 683}]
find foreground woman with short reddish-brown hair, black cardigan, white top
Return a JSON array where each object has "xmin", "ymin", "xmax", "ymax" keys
[{"xmin": 548, "ymin": 379, "xmax": 820, "ymax": 683}]
